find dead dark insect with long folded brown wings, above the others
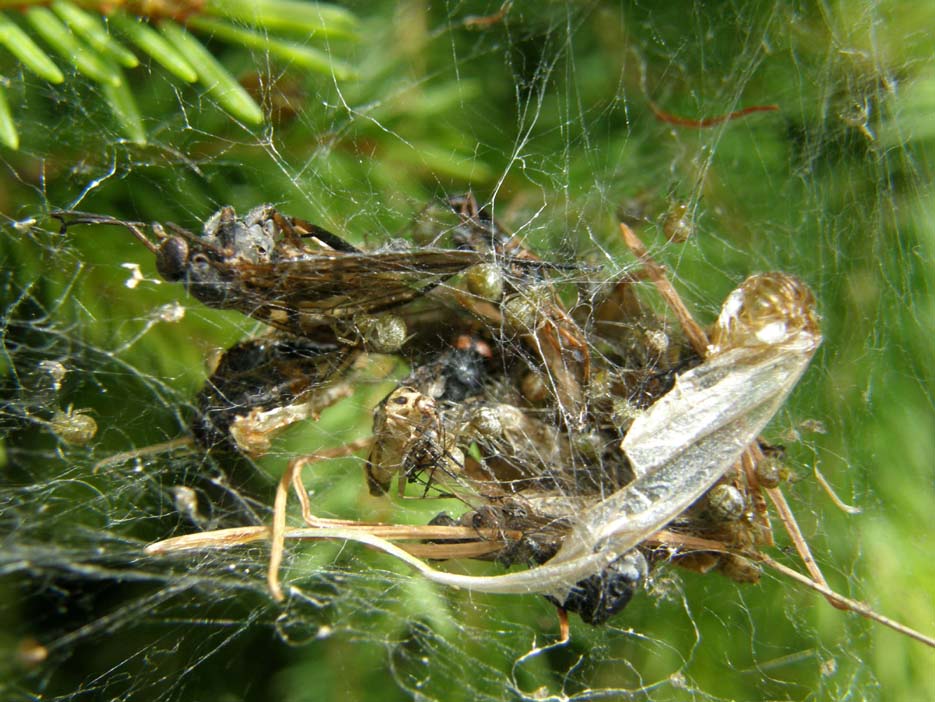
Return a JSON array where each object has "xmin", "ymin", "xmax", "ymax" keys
[{"xmin": 51, "ymin": 205, "xmax": 484, "ymax": 352}]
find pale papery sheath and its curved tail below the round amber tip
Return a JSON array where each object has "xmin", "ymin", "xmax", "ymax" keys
[{"xmin": 406, "ymin": 334, "xmax": 821, "ymax": 602}]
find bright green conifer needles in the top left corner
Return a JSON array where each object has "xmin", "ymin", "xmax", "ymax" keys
[{"xmin": 0, "ymin": 0, "xmax": 356, "ymax": 149}]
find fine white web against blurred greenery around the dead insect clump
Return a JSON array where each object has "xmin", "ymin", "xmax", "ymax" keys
[{"xmin": 0, "ymin": 0, "xmax": 935, "ymax": 700}]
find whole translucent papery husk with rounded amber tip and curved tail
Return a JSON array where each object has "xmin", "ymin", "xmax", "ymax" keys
[{"xmin": 384, "ymin": 273, "xmax": 821, "ymax": 602}]
